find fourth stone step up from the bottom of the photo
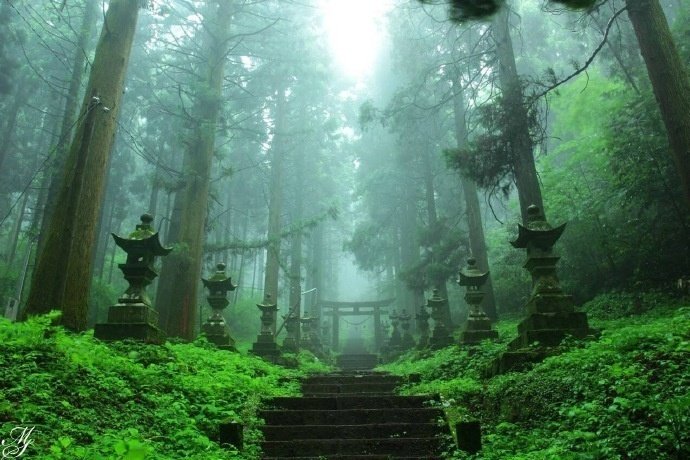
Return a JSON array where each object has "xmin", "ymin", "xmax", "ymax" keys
[{"xmin": 267, "ymin": 394, "xmax": 438, "ymax": 410}]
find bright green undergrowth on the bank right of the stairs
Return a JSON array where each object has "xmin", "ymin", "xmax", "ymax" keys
[{"xmin": 376, "ymin": 294, "xmax": 690, "ymax": 460}]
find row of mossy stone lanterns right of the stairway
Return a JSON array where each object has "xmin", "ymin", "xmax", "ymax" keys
[{"xmin": 382, "ymin": 205, "xmax": 595, "ymax": 360}]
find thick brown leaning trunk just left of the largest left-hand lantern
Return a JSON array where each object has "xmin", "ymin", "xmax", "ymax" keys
[{"xmin": 26, "ymin": 0, "xmax": 140, "ymax": 331}]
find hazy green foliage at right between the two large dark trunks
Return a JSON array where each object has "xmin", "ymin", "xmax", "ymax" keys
[{"xmin": 541, "ymin": 71, "xmax": 690, "ymax": 301}]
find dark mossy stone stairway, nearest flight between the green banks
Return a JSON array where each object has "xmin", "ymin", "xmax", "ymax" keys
[{"xmin": 262, "ymin": 372, "xmax": 448, "ymax": 460}]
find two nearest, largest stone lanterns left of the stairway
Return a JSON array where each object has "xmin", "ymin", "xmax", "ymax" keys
[{"xmin": 94, "ymin": 214, "xmax": 237, "ymax": 351}]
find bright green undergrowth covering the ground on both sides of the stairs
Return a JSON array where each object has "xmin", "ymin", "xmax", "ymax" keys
[{"xmin": 0, "ymin": 293, "xmax": 690, "ymax": 460}]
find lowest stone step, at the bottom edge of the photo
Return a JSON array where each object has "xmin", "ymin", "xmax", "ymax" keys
[{"xmin": 261, "ymin": 438, "xmax": 441, "ymax": 457}]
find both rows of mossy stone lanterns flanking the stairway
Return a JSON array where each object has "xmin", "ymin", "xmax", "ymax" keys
[{"xmin": 94, "ymin": 206, "xmax": 592, "ymax": 372}]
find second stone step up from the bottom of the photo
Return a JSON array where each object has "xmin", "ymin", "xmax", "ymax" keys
[{"xmin": 261, "ymin": 423, "xmax": 444, "ymax": 441}]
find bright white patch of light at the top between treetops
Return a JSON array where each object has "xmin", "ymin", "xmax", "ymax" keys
[{"xmin": 320, "ymin": 0, "xmax": 391, "ymax": 79}]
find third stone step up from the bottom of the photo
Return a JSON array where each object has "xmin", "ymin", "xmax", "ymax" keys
[{"xmin": 260, "ymin": 408, "xmax": 444, "ymax": 425}]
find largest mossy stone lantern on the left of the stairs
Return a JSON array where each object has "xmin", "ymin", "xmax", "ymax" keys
[{"xmin": 94, "ymin": 214, "xmax": 172, "ymax": 343}]
